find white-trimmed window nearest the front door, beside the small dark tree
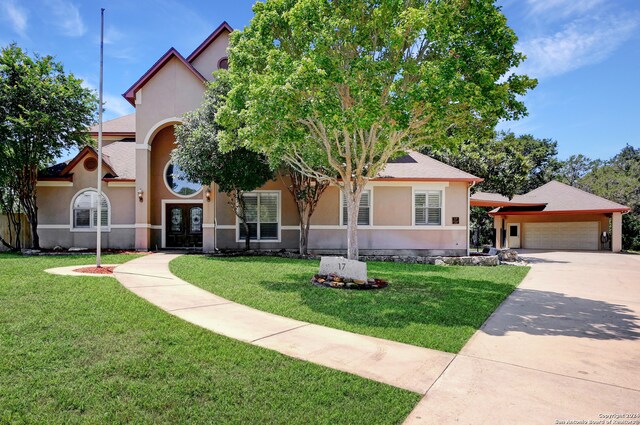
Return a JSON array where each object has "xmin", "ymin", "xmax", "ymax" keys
[{"xmin": 238, "ymin": 192, "xmax": 280, "ymax": 241}]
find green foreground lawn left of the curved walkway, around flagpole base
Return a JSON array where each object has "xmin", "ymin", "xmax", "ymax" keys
[{"xmin": 0, "ymin": 254, "xmax": 420, "ymax": 424}]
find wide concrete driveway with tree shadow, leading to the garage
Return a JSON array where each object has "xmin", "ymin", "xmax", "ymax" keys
[{"xmin": 407, "ymin": 251, "xmax": 640, "ymax": 424}]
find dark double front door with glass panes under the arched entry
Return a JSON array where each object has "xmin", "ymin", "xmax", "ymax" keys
[{"xmin": 165, "ymin": 204, "xmax": 202, "ymax": 248}]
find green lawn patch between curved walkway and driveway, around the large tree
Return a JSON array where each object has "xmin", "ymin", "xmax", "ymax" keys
[{"xmin": 170, "ymin": 255, "xmax": 529, "ymax": 353}]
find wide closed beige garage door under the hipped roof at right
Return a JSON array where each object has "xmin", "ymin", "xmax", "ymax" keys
[{"xmin": 522, "ymin": 221, "xmax": 599, "ymax": 250}]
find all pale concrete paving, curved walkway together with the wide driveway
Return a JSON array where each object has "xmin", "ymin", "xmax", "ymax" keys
[{"xmin": 114, "ymin": 252, "xmax": 640, "ymax": 424}]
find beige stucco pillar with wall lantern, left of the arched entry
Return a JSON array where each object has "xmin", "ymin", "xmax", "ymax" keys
[{"xmin": 135, "ymin": 143, "xmax": 151, "ymax": 251}]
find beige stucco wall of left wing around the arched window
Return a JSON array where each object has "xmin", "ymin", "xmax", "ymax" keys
[{"xmin": 37, "ymin": 149, "xmax": 136, "ymax": 249}]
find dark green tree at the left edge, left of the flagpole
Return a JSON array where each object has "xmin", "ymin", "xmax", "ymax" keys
[{"xmin": 0, "ymin": 44, "xmax": 97, "ymax": 248}]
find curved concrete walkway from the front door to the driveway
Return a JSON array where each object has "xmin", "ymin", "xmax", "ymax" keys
[{"xmin": 114, "ymin": 253, "xmax": 455, "ymax": 394}]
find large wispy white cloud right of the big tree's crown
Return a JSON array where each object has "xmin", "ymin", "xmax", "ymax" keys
[{"xmin": 517, "ymin": 16, "xmax": 640, "ymax": 78}]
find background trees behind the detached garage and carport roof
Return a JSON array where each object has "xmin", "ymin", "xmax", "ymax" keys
[{"xmin": 423, "ymin": 132, "xmax": 640, "ymax": 250}]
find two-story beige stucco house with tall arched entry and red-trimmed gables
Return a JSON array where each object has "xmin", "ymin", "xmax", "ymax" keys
[{"xmin": 37, "ymin": 23, "xmax": 481, "ymax": 255}]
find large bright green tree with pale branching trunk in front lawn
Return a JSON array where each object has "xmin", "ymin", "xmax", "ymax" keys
[{"xmin": 219, "ymin": 0, "xmax": 536, "ymax": 258}]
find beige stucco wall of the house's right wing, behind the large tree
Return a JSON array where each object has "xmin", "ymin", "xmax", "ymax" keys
[{"xmin": 217, "ymin": 179, "xmax": 467, "ymax": 255}]
